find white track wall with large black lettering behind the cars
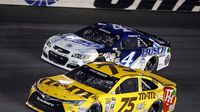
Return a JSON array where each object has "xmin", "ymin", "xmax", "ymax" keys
[{"xmin": 0, "ymin": 0, "xmax": 200, "ymax": 12}]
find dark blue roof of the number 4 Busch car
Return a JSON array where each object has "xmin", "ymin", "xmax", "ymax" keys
[{"xmin": 94, "ymin": 22, "xmax": 148, "ymax": 38}]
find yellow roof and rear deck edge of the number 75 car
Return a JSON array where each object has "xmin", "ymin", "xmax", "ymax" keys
[{"xmin": 87, "ymin": 62, "xmax": 176, "ymax": 87}]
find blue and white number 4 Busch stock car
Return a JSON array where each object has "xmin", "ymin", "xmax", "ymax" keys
[{"xmin": 41, "ymin": 22, "xmax": 171, "ymax": 71}]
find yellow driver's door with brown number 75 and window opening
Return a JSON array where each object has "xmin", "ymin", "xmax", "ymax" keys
[{"xmin": 110, "ymin": 78, "xmax": 138, "ymax": 112}]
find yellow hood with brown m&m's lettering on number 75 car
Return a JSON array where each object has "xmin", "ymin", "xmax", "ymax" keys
[{"xmin": 37, "ymin": 75, "xmax": 104, "ymax": 100}]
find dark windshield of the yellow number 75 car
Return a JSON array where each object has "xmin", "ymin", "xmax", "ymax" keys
[{"xmin": 65, "ymin": 65, "xmax": 118, "ymax": 93}]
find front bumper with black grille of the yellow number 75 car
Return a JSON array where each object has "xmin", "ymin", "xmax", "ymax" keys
[{"xmin": 26, "ymin": 86, "xmax": 87, "ymax": 112}]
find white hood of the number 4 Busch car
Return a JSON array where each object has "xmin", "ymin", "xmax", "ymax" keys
[{"xmin": 50, "ymin": 33, "xmax": 103, "ymax": 53}]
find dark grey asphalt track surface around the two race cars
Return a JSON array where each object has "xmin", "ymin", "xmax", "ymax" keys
[{"xmin": 0, "ymin": 6, "xmax": 200, "ymax": 112}]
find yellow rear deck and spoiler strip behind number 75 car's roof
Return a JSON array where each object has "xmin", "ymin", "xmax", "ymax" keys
[{"xmin": 135, "ymin": 69, "xmax": 176, "ymax": 87}]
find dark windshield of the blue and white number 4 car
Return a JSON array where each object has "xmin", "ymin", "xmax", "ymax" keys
[{"xmin": 75, "ymin": 26, "xmax": 117, "ymax": 47}]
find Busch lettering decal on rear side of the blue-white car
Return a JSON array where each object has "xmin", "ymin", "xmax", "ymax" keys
[{"xmin": 141, "ymin": 47, "xmax": 166, "ymax": 56}]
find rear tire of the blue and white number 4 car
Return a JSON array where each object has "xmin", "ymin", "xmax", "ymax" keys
[{"xmin": 144, "ymin": 57, "xmax": 158, "ymax": 72}]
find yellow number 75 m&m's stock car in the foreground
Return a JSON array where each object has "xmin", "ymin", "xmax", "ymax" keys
[{"xmin": 26, "ymin": 62, "xmax": 177, "ymax": 112}]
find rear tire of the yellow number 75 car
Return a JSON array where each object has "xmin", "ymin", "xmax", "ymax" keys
[{"xmin": 148, "ymin": 101, "xmax": 163, "ymax": 112}]
